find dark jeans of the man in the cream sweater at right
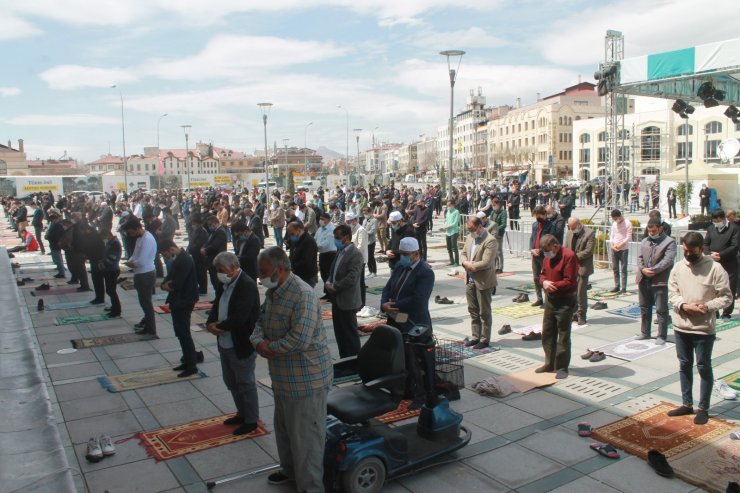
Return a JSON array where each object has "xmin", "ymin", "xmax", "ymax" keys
[{"xmin": 673, "ymin": 330, "xmax": 717, "ymax": 411}]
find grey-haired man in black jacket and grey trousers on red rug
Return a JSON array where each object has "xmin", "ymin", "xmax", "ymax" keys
[{"xmin": 206, "ymin": 252, "xmax": 260, "ymax": 435}]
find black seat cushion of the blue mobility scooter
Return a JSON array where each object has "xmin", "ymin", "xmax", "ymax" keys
[{"xmin": 327, "ymin": 385, "xmax": 398, "ymax": 424}]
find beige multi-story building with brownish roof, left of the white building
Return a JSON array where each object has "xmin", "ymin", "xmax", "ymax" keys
[{"xmin": 487, "ymin": 82, "xmax": 604, "ymax": 183}]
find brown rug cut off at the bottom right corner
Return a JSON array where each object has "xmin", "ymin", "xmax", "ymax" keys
[{"xmin": 671, "ymin": 436, "xmax": 740, "ymax": 493}]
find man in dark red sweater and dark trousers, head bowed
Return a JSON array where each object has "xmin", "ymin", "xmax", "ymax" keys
[{"xmin": 535, "ymin": 235, "xmax": 578, "ymax": 379}]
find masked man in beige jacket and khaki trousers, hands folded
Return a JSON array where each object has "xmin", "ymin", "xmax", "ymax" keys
[{"xmin": 462, "ymin": 217, "xmax": 498, "ymax": 349}]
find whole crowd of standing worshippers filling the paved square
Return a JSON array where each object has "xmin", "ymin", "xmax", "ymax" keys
[{"xmin": 3, "ymin": 176, "xmax": 740, "ymax": 491}]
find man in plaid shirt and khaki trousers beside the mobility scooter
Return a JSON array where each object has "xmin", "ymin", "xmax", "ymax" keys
[{"xmin": 251, "ymin": 248, "xmax": 330, "ymax": 493}]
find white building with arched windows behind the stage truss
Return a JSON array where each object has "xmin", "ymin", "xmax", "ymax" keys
[{"xmin": 572, "ymin": 97, "xmax": 740, "ymax": 181}]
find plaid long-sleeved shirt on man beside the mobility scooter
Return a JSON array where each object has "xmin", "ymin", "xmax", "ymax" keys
[{"xmin": 250, "ymin": 274, "xmax": 332, "ymax": 398}]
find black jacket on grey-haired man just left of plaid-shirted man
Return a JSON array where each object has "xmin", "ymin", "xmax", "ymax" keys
[{"xmin": 207, "ymin": 271, "xmax": 260, "ymax": 359}]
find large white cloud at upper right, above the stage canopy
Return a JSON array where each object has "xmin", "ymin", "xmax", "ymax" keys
[{"xmin": 534, "ymin": 0, "xmax": 740, "ymax": 65}]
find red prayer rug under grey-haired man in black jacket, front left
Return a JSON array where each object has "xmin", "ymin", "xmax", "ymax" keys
[{"xmin": 137, "ymin": 416, "xmax": 269, "ymax": 461}]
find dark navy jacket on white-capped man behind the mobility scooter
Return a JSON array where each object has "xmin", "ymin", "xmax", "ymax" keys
[{"xmin": 380, "ymin": 260, "xmax": 434, "ymax": 332}]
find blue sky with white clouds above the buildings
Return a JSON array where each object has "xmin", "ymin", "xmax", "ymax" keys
[{"xmin": 0, "ymin": 0, "xmax": 740, "ymax": 161}]
